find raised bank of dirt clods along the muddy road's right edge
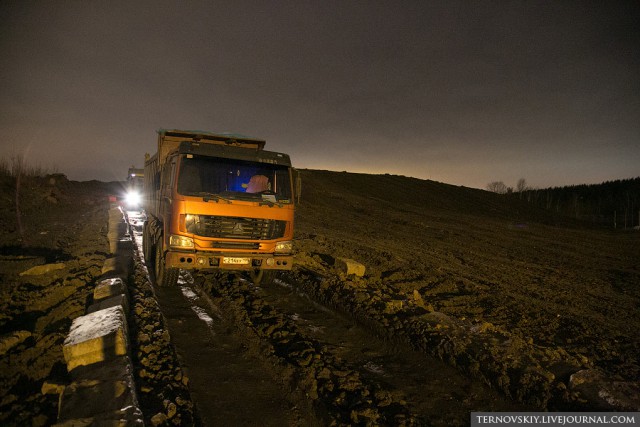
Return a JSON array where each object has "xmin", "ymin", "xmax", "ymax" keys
[{"xmin": 286, "ymin": 268, "xmax": 589, "ymax": 411}]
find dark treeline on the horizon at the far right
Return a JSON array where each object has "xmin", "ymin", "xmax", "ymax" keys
[{"xmin": 506, "ymin": 177, "xmax": 640, "ymax": 228}]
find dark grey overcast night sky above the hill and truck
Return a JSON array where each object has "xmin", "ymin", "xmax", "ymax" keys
[{"xmin": 0, "ymin": 0, "xmax": 640, "ymax": 188}]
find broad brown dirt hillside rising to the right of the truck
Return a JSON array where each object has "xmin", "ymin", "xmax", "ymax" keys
[{"xmin": 296, "ymin": 170, "xmax": 640, "ymax": 392}]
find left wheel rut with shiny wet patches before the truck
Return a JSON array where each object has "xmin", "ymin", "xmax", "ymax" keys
[{"xmin": 156, "ymin": 272, "xmax": 313, "ymax": 426}]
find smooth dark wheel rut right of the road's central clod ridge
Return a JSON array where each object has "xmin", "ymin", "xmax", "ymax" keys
[{"xmin": 260, "ymin": 280, "xmax": 532, "ymax": 426}]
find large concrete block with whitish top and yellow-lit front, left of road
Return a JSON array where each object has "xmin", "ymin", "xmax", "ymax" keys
[{"xmin": 62, "ymin": 306, "xmax": 128, "ymax": 371}]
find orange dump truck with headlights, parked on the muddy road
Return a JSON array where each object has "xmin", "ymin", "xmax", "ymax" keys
[{"xmin": 143, "ymin": 130, "xmax": 294, "ymax": 286}]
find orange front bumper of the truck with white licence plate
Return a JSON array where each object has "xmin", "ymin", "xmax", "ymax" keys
[{"xmin": 165, "ymin": 251, "xmax": 293, "ymax": 270}]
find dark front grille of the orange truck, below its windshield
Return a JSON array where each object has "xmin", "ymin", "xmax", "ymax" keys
[{"xmin": 187, "ymin": 215, "xmax": 287, "ymax": 240}]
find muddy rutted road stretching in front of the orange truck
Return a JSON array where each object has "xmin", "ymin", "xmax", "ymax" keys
[{"xmin": 128, "ymin": 212, "xmax": 535, "ymax": 426}]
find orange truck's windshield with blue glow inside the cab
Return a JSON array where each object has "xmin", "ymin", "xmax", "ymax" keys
[{"xmin": 178, "ymin": 155, "xmax": 292, "ymax": 203}]
